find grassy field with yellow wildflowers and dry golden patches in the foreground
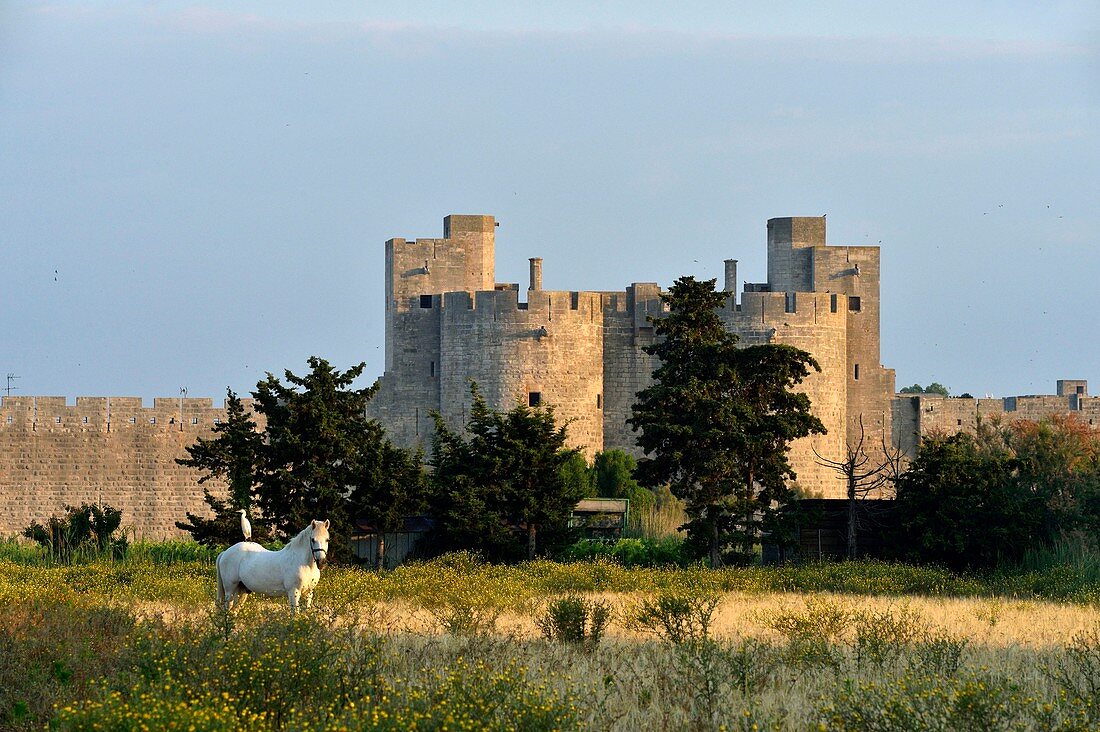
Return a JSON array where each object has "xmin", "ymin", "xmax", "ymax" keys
[{"xmin": 0, "ymin": 546, "xmax": 1100, "ymax": 731}]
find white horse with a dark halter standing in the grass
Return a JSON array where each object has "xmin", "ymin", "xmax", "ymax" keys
[{"xmin": 215, "ymin": 520, "xmax": 329, "ymax": 613}]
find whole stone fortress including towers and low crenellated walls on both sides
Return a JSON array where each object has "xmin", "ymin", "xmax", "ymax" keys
[{"xmin": 0, "ymin": 215, "xmax": 1100, "ymax": 539}]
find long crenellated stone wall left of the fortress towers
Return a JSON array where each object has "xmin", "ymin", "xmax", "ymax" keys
[{"xmin": 0, "ymin": 396, "xmax": 232, "ymax": 539}]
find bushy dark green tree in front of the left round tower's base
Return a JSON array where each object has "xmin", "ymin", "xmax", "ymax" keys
[{"xmin": 431, "ymin": 384, "xmax": 583, "ymax": 559}]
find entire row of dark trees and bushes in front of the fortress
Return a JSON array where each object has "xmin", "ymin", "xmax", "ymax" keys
[{"xmin": 171, "ymin": 272, "xmax": 1100, "ymax": 569}]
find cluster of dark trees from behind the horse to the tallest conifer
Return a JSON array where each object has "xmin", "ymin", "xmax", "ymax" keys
[{"xmin": 177, "ymin": 358, "xmax": 656, "ymax": 565}]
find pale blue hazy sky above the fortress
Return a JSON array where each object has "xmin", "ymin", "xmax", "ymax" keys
[{"xmin": 0, "ymin": 0, "xmax": 1100, "ymax": 403}]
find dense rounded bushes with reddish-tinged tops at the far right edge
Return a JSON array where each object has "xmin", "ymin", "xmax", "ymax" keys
[{"xmin": 894, "ymin": 417, "xmax": 1100, "ymax": 569}]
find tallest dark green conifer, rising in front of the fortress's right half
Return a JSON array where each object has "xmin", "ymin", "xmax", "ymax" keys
[{"xmin": 628, "ymin": 277, "xmax": 825, "ymax": 567}]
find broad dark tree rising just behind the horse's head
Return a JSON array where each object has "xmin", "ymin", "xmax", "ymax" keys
[{"xmin": 253, "ymin": 357, "xmax": 384, "ymax": 558}]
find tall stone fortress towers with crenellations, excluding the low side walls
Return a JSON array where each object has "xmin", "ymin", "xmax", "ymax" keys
[{"xmin": 369, "ymin": 215, "xmax": 894, "ymax": 498}]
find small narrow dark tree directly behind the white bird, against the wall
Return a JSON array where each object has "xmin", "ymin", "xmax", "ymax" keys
[{"xmin": 176, "ymin": 389, "xmax": 271, "ymax": 546}]
